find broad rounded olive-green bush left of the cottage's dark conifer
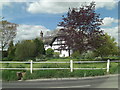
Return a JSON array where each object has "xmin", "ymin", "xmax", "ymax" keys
[{"xmin": 15, "ymin": 40, "xmax": 36, "ymax": 60}]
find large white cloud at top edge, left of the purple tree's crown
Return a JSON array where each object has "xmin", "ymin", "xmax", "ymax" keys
[{"xmin": 27, "ymin": 0, "xmax": 80, "ymax": 14}]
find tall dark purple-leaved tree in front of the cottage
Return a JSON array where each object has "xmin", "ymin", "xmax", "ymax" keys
[{"xmin": 58, "ymin": 2, "xmax": 104, "ymax": 53}]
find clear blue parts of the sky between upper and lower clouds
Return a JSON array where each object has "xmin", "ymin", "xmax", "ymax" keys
[{"xmin": 2, "ymin": 2, "xmax": 118, "ymax": 30}]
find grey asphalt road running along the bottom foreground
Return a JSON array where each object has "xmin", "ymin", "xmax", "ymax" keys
[{"xmin": 2, "ymin": 75, "xmax": 120, "ymax": 88}]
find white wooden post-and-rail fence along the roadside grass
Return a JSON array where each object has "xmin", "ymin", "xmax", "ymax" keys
[{"xmin": 0, "ymin": 60, "xmax": 110, "ymax": 73}]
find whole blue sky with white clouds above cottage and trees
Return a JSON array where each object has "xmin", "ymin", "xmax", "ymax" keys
[{"xmin": 0, "ymin": 0, "xmax": 119, "ymax": 42}]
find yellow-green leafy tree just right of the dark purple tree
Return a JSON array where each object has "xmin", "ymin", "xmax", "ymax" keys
[{"xmin": 94, "ymin": 33, "xmax": 118, "ymax": 57}]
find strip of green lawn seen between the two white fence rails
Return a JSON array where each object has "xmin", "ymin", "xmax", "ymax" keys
[{"xmin": 0, "ymin": 62, "xmax": 118, "ymax": 68}]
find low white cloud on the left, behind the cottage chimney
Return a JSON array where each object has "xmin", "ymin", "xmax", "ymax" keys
[{"xmin": 14, "ymin": 25, "xmax": 50, "ymax": 42}]
